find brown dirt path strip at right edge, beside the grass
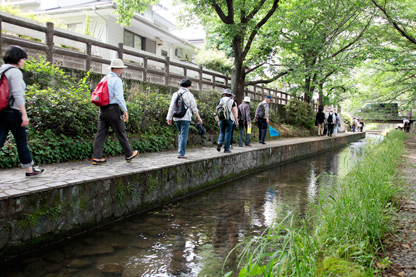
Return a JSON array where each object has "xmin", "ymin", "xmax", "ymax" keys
[{"xmin": 377, "ymin": 135, "xmax": 416, "ymax": 277}]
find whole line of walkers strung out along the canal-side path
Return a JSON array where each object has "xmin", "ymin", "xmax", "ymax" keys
[{"xmin": 0, "ymin": 46, "xmax": 370, "ymax": 177}]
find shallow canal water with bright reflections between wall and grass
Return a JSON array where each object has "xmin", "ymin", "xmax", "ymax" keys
[{"xmin": 0, "ymin": 137, "xmax": 372, "ymax": 277}]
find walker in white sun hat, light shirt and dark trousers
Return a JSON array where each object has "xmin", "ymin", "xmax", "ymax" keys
[{"xmin": 92, "ymin": 59, "xmax": 139, "ymax": 165}]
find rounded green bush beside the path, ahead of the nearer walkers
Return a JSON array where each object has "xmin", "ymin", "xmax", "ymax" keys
[{"xmin": 286, "ymin": 98, "xmax": 315, "ymax": 129}]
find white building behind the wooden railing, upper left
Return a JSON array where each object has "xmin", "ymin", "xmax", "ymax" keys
[{"xmin": 8, "ymin": 0, "xmax": 200, "ymax": 62}]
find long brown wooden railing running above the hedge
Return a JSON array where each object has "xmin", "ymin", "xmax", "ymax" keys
[{"xmin": 0, "ymin": 12, "xmax": 316, "ymax": 109}]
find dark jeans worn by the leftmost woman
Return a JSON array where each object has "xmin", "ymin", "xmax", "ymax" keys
[{"xmin": 0, "ymin": 109, "xmax": 33, "ymax": 168}]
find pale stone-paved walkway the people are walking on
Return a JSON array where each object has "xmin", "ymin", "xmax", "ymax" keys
[{"xmin": 0, "ymin": 133, "xmax": 348, "ymax": 200}]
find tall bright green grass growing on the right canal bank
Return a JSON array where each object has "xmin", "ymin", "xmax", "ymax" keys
[{"xmin": 231, "ymin": 131, "xmax": 407, "ymax": 276}]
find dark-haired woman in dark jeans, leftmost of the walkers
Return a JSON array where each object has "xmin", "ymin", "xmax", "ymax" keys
[{"xmin": 0, "ymin": 45, "xmax": 45, "ymax": 177}]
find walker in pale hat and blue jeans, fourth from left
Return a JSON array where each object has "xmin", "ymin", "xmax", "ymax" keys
[{"xmin": 217, "ymin": 88, "xmax": 238, "ymax": 153}]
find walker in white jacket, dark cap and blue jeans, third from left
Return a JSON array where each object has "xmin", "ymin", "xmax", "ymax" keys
[{"xmin": 166, "ymin": 78, "xmax": 202, "ymax": 159}]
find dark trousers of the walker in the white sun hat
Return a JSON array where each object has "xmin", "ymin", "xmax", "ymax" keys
[{"xmin": 94, "ymin": 104, "xmax": 133, "ymax": 159}]
